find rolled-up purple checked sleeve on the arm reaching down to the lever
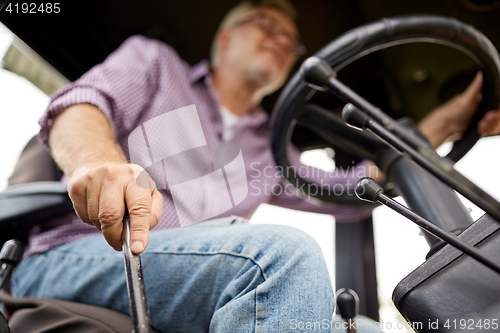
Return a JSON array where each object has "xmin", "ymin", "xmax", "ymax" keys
[{"xmin": 38, "ymin": 36, "xmax": 159, "ymax": 151}]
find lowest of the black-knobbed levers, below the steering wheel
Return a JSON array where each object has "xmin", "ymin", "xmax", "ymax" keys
[{"xmin": 354, "ymin": 177, "xmax": 500, "ymax": 273}]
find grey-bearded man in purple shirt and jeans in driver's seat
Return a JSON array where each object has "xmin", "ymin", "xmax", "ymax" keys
[{"xmin": 12, "ymin": 0, "xmax": 499, "ymax": 332}]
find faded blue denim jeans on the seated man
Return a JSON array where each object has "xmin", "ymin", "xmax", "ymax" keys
[{"xmin": 12, "ymin": 217, "xmax": 378, "ymax": 333}]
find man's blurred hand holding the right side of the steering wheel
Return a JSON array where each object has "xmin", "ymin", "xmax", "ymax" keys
[{"xmin": 419, "ymin": 72, "xmax": 500, "ymax": 148}]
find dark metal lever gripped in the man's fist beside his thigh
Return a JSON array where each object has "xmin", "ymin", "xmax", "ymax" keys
[{"xmin": 122, "ymin": 211, "xmax": 151, "ymax": 333}]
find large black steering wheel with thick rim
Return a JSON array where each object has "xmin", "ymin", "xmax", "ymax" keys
[{"xmin": 270, "ymin": 15, "xmax": 500, "ymax": 204}]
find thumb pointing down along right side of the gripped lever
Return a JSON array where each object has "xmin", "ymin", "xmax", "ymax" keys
[{"xmin": 125, "ymin": 182, "xmax": 152, "ymax": 254}]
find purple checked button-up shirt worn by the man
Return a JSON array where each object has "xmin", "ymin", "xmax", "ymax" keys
[{"xmin": 28, "ymin": 36, "xmax": 371, "ymax": 253}]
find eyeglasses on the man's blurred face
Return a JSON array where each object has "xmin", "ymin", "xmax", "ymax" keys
[{"xmin": 233, "ymin": 13, "xmax": 307, "ymax": 59}]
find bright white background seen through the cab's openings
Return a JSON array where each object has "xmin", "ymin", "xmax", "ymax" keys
[{"xmin": 0, "ymin": 24, "xmax": 500, "ymax": 332}]
